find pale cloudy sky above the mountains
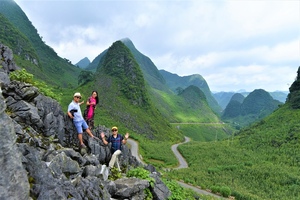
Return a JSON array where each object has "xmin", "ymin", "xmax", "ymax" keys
[{"xmin": 15, "ymin": 0, "xmax": 300, "ymax": 92}]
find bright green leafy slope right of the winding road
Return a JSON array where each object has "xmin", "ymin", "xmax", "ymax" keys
[{"xmin": 169, "ymin": 105, "xmax": 300, "ymax": 199}]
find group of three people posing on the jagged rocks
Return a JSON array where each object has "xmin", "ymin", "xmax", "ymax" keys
[{"xmin": 68, "ymin": 91, "xmax": 129, "ymax": 168}]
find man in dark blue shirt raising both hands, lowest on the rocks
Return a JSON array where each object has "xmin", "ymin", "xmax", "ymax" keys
[{"xmin": 101, "ymin": 126, "xmax": 129, "ymax": 170}]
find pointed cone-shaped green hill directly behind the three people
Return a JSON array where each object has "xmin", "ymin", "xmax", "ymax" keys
[{"xmin": 88, "ymin": 41, "xmax": 183, "ymax": 141}]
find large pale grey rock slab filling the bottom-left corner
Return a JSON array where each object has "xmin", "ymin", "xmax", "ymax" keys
[{"xmin": 0, "ymin": 89, "xmax": 29, "ymax": 200}]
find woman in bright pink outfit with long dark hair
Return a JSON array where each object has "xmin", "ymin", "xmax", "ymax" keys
[{"xmin": 84, "ymin": 91, "xmax": 99, "ymax": 129}]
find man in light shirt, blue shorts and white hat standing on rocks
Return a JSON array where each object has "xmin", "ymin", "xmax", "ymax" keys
[{"xmin": 68, "ymin": 92, "xmax": 94, "ymax": 148}]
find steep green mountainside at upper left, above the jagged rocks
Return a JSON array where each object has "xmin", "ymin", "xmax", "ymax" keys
[{"xmin": 0, "ymin": 0, "xmax": 81, "ymax": 87}]
